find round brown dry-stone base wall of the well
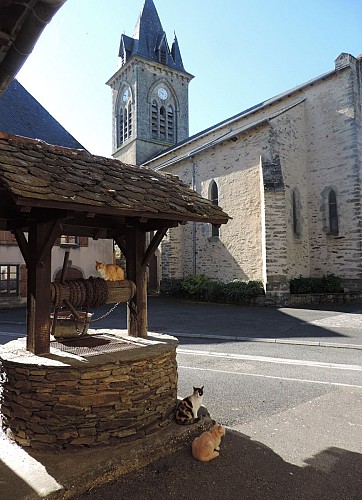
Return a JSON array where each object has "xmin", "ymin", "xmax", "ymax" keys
[{"xmin": 1, "ymin": 344, "xmax": 177, "ymax": 449}]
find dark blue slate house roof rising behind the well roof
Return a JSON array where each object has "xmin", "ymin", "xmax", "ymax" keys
[{"xmin": 0, "ymin": 80, "xmax": 84, "ymax": 149}]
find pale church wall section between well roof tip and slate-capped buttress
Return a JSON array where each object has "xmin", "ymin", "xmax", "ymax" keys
[{"xmin": 163, "ymin": 126, "xmax": 269, "ymax": 281}]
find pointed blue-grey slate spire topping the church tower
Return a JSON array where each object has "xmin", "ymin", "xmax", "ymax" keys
[{"xmin": 119, "ymin": 0, "xmax": 185, "ymax": 71}]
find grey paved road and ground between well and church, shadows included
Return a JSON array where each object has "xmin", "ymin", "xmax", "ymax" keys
[{"xmin": 0, "ymin": 297, "xmax": 362, "ymax": 500}]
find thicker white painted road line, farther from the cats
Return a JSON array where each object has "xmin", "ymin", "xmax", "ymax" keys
[{"xmin": 177, "ymin": 348, "xmax": 362, "ymax": 371}]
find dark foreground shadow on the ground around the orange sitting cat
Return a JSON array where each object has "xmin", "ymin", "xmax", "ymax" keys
[{"xmin": 77, "ymin": 430, "xmax": 362, "ymax": 500}]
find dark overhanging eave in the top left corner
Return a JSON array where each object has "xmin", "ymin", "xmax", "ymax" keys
[{"xmin": 0, "ymin": 0, "xmax": 66, "ymax": 93}]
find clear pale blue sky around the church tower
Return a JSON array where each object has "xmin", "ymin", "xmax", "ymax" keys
[{"xmin": 18, "ymin": 0, "xmax": 362, "ymax": 156}]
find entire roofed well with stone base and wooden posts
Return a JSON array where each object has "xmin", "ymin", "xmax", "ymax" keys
[{"xmin": 0, "ymin": 134, "xmax": 228, "ymax": 449}]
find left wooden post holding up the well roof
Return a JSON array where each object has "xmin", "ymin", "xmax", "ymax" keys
[{"xmin": 26, "ymin": 223, "xmax": 56, "ymax": 355}]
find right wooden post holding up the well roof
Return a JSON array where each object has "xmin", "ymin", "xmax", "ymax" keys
[{"xmin": 126, "ymin": 229, "xmax": 148, "ymax": 338}]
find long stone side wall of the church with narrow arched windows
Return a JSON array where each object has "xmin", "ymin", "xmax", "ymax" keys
[{"xmin": 150, "ymin": 57, "xmax": 362, "ymax": 292}]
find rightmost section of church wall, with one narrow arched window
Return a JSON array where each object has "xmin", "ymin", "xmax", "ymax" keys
[{"xmin": 306, "ymin": 67, "xmax": 362, "ymax": 282}]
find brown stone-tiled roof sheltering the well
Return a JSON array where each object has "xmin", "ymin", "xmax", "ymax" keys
[{"xmin": 0, "ymin": 134, "xmax": 229, "ymax": 225}]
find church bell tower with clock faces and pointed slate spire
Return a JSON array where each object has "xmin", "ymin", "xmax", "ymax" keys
[{"xmin": 107, "ymin": 0, "xmax": 193, "ymax": 165}]
